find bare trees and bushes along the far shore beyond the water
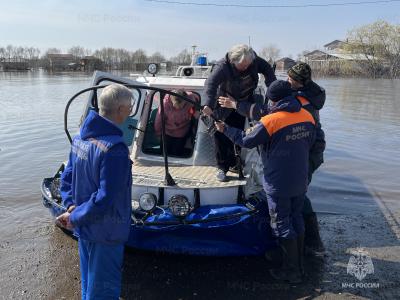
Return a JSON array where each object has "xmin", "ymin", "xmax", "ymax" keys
[{"xmin": 0, "ymin": 21, "xmax": 400, "ymax": 78}]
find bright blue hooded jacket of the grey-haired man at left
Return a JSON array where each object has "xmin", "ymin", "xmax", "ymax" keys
[{"xmin": 61, "ymin": 111, "xmax": 132, "ymax": 243}]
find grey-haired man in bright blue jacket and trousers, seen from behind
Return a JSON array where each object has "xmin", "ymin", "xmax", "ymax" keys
[{"xmin": 57, "ymin": 84, "xmax": 132, "ymax": 299}]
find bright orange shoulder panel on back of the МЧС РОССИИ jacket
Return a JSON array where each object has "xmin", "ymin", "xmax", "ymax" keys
[{"xmin": 260, "ymin": 108, "xmax": 315, "ymax": 136}]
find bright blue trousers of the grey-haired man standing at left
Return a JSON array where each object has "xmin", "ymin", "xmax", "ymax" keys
[{"xmin": 78, "ymin": 239, "xmax": 124, "ymax": 300}]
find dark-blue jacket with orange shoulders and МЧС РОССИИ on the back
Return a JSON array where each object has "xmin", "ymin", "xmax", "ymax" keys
[{"xmin": 224, "ymin": 96, "xmax": 315, "ymax": 197}]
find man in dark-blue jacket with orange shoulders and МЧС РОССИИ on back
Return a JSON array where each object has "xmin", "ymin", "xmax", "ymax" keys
[{"xmin": 216, "ymin": 80, "xmax": 315, "ymax": 283}]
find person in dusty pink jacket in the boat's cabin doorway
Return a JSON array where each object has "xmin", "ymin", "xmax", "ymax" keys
[{"xmin": 154, "ymin": 89, "xmax": 199, "ymax": 156}]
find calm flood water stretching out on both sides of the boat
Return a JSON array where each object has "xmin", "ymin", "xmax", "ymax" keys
[{"xmin": 0, "ymin": 72, "xmax": 400, "ymax": 298}]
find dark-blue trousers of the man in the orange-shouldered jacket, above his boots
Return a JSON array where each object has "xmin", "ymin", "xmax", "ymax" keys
[{"xmin": 267, "ymin": 194, "xmax": 305, "ymax": 239}]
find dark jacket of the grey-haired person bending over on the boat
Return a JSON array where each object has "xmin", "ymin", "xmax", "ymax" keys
[{"xmin": 204, "ymin": 54, "xmax": 276, "ymax": 119}]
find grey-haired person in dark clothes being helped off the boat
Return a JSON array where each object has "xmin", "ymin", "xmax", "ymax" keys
[{"xmin": 203, "ymin": 45, "xmax": 276, "ymax": 181}]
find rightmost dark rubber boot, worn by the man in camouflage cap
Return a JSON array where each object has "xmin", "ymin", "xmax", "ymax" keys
[{"xmin": 303, "ymin": 212, "xmax": 325, "ymax": 255}]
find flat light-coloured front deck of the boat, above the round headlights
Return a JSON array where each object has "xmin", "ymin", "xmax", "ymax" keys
[{"xmin": 132, "ymin": 160, "xmax": 246, "ymax": 188}]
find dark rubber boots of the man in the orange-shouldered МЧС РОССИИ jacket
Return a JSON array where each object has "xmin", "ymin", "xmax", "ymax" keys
[{"xmin": 270, "ymin": 239, "xmax": 302, "ymax": 284}]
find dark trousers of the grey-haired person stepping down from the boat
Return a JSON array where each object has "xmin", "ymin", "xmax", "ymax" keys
[{"xmin": 214, "ymin": 111, "xmax": 246, "ymax": 172}]
